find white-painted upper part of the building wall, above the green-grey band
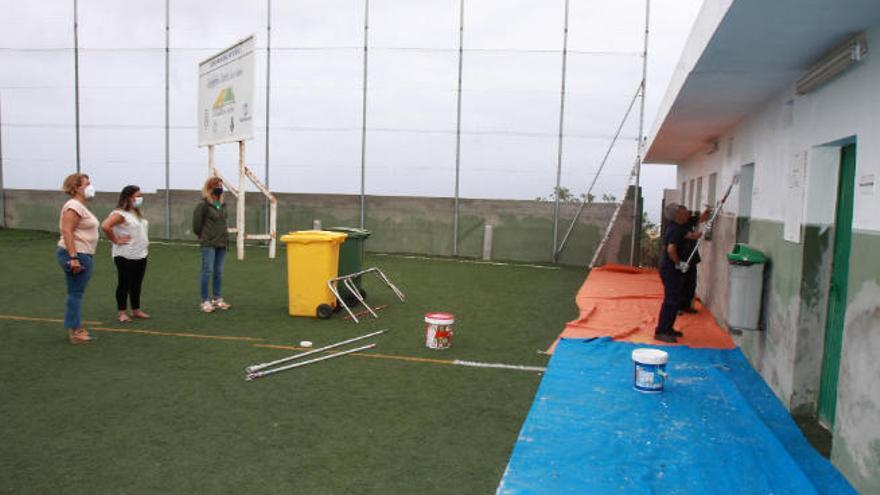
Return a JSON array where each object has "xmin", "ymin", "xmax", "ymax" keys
[{"xmin": 676, "ymin": 28, "xmax": 880, "ymax": 231}]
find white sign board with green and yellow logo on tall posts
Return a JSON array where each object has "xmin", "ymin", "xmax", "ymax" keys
[{"xmin": 198, "ymin": 36, "xmax": 256, "ymax": 146}]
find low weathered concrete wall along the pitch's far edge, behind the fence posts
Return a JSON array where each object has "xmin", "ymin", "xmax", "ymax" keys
[{"xmin": 5, "ymin": 189, "xmax": 632, "ymax": 266}]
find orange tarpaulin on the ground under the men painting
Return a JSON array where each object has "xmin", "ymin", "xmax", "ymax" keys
[{"xmin": 547, "ymin": 265, "xmax": 736, "ymax": 353}]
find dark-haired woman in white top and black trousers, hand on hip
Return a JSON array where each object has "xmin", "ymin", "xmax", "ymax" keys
[{"xmin": 101, "ymin": 186, "xmax": 150, "ymax": 322}]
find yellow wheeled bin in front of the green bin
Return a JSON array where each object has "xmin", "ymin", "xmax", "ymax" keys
[{"xmin": 281, "ymin": 230, "xmax": 348, "ymax": 318}]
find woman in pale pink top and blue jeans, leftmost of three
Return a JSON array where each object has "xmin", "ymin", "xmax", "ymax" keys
[{"xmin": 55, "ymin": 173, "xmax": 98, "ymax": 344}]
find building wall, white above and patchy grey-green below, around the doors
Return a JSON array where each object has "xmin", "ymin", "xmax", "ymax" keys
[{"xmin": 677, "ymin": 28, "xmax": 880, "ymax": 493}]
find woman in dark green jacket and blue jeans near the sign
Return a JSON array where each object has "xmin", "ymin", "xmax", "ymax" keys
[{"xmin": 193, "ymin": 177, "xmax": 231, "ymax": 313}]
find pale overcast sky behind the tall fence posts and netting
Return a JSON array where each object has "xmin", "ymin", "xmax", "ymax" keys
[{"xmin": 0, "ymin": 0, "xmax": 701, "ymax": 218}]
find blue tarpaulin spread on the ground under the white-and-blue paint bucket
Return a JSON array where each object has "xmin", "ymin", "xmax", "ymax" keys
[{"xmin": 498, "ymin": 338, "xmax": 855, "ymax": 495}]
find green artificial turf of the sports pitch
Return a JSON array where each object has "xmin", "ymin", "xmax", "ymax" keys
[{"xmin": 0, "ymin": 230, "xmax": 585, "ymax": 493}]
